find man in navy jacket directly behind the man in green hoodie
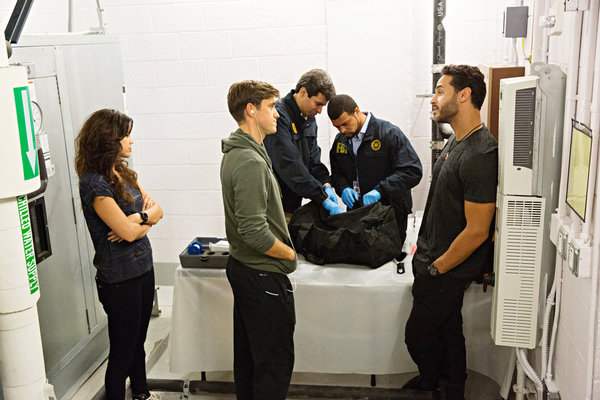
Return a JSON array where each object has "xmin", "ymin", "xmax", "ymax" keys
[{"xmin": 264, "ymin": 69, "xmax": 344, "ymax": 222}]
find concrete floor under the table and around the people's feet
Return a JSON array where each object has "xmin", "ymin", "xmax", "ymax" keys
[{"xmin": 72, "ymin": 286, "xmax": 501, "ymax": 400}]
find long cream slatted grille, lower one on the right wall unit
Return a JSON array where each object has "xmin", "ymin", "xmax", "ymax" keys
[{"xmin": 500, "ymin": 200, "xmax": 543, "ymax": 347}]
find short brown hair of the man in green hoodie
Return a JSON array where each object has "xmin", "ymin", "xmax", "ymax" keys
[{"xmin": 227, "ymin": 80, "xmax": 279, "ymax": 124}]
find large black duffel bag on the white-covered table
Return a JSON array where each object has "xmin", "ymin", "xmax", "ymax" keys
[{"xmin": 288, "ymin": 202, "xmax": 403, "ymax": 268}]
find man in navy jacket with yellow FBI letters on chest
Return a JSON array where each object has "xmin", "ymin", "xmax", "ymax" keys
[{"xmin": 327, "ymin": 94, "xmax": 423, "ymax": 247}]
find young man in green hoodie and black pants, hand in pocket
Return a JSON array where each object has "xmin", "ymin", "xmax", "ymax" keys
[{"xmin": 221, "ymin": 81, "xmax": 296, "ymax": 400}]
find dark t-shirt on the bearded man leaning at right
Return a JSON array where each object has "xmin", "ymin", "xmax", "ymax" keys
[{"xmin": 413, "ymin": 126, "xmax": 498, "ymax": 278}]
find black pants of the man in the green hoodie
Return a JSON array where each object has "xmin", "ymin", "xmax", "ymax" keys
[{"xmin": 227, "ymin": 256, "xmax": 296, "ymax": 400}]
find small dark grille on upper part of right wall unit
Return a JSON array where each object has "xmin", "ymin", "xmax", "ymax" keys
[{"xmin": 513, "ymin": 88, "xmax": 536, "ymax": 169}]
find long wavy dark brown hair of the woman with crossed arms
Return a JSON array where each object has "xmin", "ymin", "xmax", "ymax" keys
[{"xmin": 75, "ymin": 108, "xmax": 139, "ymax": 202}]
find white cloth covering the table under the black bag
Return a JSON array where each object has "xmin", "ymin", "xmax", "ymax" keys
[{"xmin": 169, "ymin": 260, "xmax": 510, "ymax": 383}]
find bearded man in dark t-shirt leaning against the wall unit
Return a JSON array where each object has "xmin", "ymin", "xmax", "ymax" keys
[{"xmin": 404, "ymin": 65, "xmax": 498, "ymax": 400}]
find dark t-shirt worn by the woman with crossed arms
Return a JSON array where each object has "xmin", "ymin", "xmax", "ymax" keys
[{"xmin": 79, "ymin": 173, "xmax": 153, "ymax": 283}]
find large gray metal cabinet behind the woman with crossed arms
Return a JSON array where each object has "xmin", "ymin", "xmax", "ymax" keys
[{"xmin": 10, "ymin": 35, "xmax": 124, "ymax": 398}]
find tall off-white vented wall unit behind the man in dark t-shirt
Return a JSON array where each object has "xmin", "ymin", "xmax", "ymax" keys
[{"xmin": 491, "ymin": 63, "xmax": 566, "ymax": 349}]
